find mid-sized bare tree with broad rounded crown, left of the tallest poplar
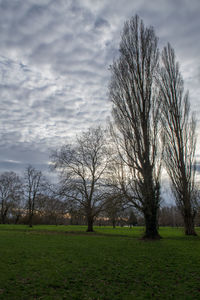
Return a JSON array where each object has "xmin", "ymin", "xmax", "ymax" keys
[{"xmin": 52, "ymin": 127, "xmax": 108, "ymax": 231}]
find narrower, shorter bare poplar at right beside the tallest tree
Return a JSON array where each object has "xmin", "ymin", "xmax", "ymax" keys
[{"xmin": 160, "ymin": 44, "xmax": 197, "ymax": 235}]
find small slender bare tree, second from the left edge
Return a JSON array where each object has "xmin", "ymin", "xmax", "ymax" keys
[{"xmin": 24, "ymin": 165, "xmax": 43, "ymax": 227}]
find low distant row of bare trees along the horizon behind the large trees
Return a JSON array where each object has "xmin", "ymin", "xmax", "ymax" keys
[{"xmin": 0, "ymin": 166, "xmax": 200, "ymax": 228}]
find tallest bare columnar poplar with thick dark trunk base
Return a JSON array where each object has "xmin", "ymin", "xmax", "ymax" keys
[{"xmin": 109, "ymin": 15, "xmax": 160, "ymax": 239}]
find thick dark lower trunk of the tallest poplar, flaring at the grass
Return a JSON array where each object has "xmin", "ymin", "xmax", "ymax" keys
[{"xmin": 143, "ymin": 210, "xmax": 161, "ymax": 240}]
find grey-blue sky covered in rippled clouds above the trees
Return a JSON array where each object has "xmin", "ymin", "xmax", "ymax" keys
[{"xmin": 0, "ymin": 0, "xmax": 200, "ymax": 179}]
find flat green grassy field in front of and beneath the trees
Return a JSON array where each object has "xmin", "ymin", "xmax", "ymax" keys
[{"xmin": 0, "ymin": 225, "xmax": 200, "ymax": 300}]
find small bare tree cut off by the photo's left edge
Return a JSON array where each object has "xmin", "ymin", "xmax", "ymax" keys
[{"xmin": 0, "ymin": 172, "xmax": 23, "ymax": 224}]
